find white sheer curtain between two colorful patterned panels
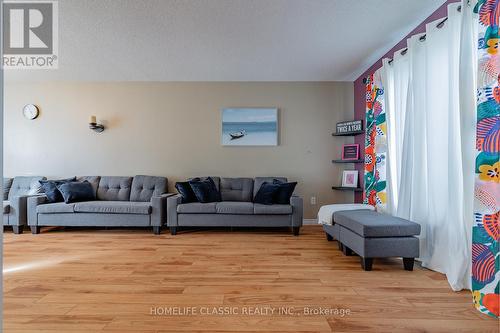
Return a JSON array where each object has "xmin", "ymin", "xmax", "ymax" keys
[{"xmin": 380, "ymin": 0, "xmax": 477, "ymax": 290}]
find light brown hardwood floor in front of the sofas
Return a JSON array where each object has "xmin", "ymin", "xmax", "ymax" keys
[{"xmin": 4, "ymin": 226, "xmax": 499, "ymax": 333}]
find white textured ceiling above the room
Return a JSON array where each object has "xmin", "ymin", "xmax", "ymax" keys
[{"xmin": 5, "ymin": 0, "xmax": 445, "ymax": 81}]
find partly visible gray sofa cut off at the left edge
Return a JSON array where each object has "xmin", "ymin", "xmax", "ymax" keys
[{"xmin": 3, "ymin": 176, "xmax": 45, "ymax": 234}]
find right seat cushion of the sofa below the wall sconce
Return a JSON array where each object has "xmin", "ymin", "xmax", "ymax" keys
[{"xmin": 75, "ymin": 201, "xmax": 151, "ymax": 215}]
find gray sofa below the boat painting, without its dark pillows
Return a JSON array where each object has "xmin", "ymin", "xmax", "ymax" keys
[{"xmin": 167, "ymin": 177, "xmax": 303, "ymax": 236}]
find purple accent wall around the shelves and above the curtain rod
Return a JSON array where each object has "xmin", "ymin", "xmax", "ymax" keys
[{"xmin": 354, "ymin": 0, "xmax": 460, "ymax": 203}]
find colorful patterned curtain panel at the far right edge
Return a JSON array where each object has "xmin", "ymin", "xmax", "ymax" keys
[{"xmin": 472, "ymin": 0, "xmax": 500, "ymax": 317}]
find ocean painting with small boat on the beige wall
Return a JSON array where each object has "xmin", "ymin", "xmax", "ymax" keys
[{"xmin": 221, "ymin": 108, "xmax": 278, "ymax": 146}]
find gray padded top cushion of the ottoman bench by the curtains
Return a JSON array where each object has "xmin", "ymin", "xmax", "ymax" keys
[{"xmin": 333, "ymin": 209, "xmax": 420, "ymax": 237}]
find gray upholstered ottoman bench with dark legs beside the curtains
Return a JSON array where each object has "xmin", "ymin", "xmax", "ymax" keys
[{"xmin": 324, "ymin": 210, "xmax": 420, "ymax": 271}]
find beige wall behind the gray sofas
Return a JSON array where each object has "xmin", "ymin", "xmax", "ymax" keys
[{"xmin": 4, "ymin": 82, "xmax": 354, "ymax": 218}]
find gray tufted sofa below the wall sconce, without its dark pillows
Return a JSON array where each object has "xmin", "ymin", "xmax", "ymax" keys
[{"xmin": 28, "ymin": 176, "xmax": 173, "ymax": 234}]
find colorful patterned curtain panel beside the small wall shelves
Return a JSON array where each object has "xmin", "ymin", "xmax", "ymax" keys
[{"xmin": 363, "ymin": 72, "xmax": 387, "ymax": 211}]
